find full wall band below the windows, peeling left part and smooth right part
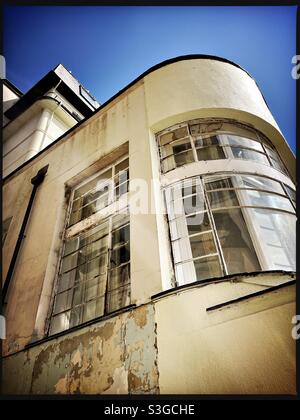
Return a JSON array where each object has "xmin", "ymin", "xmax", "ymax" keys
[{"xmin": 3, "ymin": 274, "xmax": 296, "ymax": 395}]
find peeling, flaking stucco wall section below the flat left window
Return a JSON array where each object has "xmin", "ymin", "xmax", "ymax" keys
[{"xmin": 2, "ymin": 305, "xmax": 158, "ymax": 394}]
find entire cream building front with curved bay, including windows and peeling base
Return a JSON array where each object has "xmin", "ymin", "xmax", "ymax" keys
[{"xmin": 3, "ymin": 55, "xmax": 296, "ymax": 394}]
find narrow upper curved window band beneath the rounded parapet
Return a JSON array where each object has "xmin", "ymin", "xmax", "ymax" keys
[{"xmin": 157, "ymin": 120, "xmax": 286, "ymax": 173}]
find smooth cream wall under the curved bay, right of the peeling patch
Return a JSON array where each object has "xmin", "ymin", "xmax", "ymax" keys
[{"xmin": 155, "ymin": 277, "xmax": 296, "ymax": 395}]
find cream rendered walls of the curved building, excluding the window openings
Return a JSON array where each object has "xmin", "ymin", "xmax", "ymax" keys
[{"xmin": 3, "ymin": 56, "xmax": 296, "ymax": 394}]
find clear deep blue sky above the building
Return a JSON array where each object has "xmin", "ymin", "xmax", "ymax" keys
[{"xmin": 3, "ymin": 6, "xmax": 296, "ymax": 151}]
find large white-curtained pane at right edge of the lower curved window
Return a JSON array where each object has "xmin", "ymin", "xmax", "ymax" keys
[{"xmin": 250, "ymin": 209, "xmax": 296, "ymax": 271}]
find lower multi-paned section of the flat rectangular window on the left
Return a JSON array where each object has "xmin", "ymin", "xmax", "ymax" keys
[{"xmin": 50, "ymin": 213, "xmax": 130, "ymax": 334}]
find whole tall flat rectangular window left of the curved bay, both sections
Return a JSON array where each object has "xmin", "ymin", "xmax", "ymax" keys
[{"xmin": 49, "ymin": 159, "xmax": 130, "ymax": 335}]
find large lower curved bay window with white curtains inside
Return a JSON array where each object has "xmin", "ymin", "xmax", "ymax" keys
[{"xmin": 165, "ymin": 173, "xmax": 296, "ymax": 285}]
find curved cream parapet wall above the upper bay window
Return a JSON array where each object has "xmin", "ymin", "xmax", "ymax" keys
[{"xmin": 144, "ymin": 59, "xmax": 295, "ymax": 178}]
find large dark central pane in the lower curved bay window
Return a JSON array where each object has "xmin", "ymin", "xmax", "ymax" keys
[{"xmin": 213, "ymin": 209, "xmax": 260, "ymax": 274}]
